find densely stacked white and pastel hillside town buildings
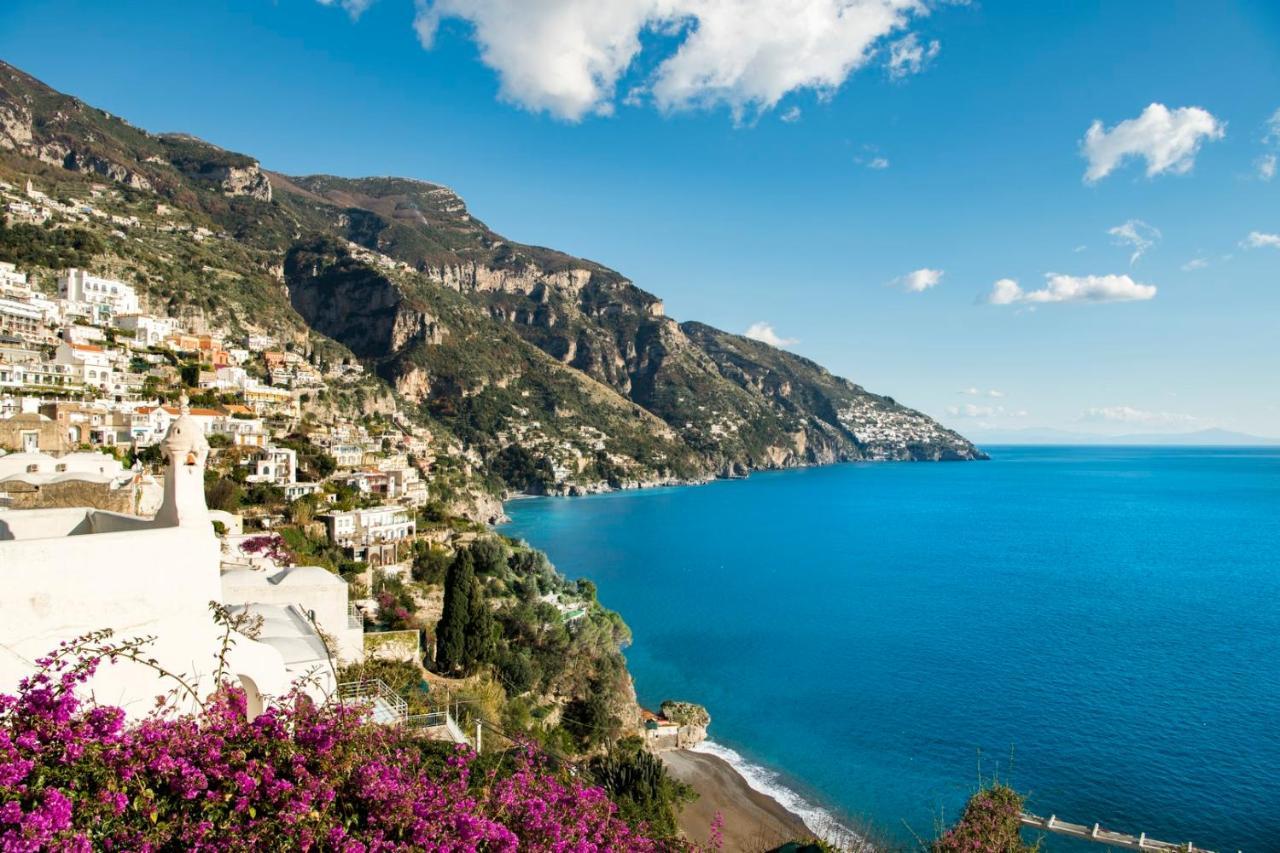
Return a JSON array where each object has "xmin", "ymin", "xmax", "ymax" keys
[{"xmin": 0, "ymin": 199, "xmax": 455, "ymax": 722}]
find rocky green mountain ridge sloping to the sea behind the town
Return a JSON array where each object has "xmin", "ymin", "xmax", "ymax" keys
[{"xmin": 0, "ymin": 63, "xmax": 982, "ymax": 493}]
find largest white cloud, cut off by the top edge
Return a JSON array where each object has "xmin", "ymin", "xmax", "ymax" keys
[{"xmin": 415, "ymin": 0, "xmax": 929, "ymax": 120}]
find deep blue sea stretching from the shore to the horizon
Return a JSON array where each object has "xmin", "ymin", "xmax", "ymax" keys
[{"xmin": 504, "ymin": 447, "xmax": 1280, "ymax": 850}]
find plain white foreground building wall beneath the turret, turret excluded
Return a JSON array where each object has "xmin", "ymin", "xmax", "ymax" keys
[{"xmin": 0, "ymin": 522, "xmax": 288, "ymax": 716}]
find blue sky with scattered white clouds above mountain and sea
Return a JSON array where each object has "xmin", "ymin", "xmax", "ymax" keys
[{"xmin": 0, "ymin": 0, "xmax": 1280, "ymax": 435}]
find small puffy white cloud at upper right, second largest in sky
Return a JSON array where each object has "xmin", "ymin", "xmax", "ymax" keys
[{"xmin": 1080, "ymin": 104, "xmax": 1226, "ymax": 183}]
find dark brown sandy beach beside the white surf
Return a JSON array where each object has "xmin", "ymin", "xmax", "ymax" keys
[{"xmin": 662, "ymin": 749, "xmax": 813, "ymax": 853}]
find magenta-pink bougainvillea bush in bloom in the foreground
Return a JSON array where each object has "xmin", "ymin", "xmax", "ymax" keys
[{"xmin": 0, "ymin": 634, "xmax": 691, "ymax": 853}]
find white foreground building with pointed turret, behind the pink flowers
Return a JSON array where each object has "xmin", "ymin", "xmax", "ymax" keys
[{"xmin": 0, "ymin": 394, "xmax": 334, "ymax": 717}]
